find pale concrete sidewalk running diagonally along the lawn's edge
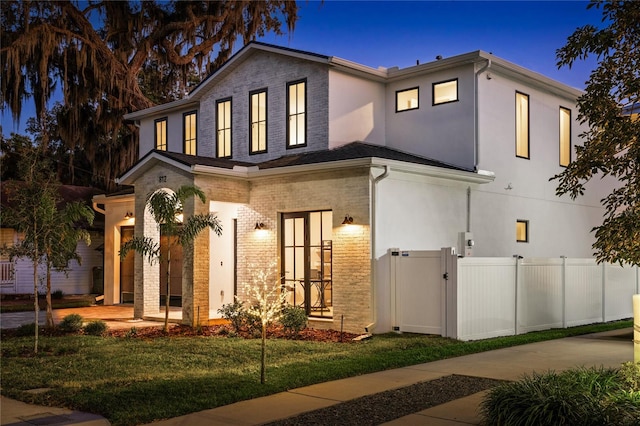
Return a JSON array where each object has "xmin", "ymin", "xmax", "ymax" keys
[{"xmin": 1, "ymin": 328, "xmax": 633, "ymax": 426}]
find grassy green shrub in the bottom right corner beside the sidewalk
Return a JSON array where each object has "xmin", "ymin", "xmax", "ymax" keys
[{"xmin": 480, "ymin": 368, "xmax": 640, "ymax": 426}]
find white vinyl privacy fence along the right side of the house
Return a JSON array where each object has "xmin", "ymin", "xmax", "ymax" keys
[{"xmin": 392, "ymin": 249, "xmax": 640, "ymax": 340}]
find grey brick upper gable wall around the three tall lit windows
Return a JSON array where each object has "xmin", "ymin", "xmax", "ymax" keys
[{"xmin": 198, "ymin": 52, "xmax": 329, "ymax": 162}]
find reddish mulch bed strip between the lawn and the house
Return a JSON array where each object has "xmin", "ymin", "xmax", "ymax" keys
[{"xmin": 107, "ymin": 324, "xmax": 358, "ymax": 343}]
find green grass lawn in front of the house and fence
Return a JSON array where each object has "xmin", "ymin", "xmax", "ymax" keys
[{"xmin": 0, "ymin": 321, "xmax": 632, "ymax": 425}]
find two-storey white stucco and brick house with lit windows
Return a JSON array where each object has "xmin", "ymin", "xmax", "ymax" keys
[{"xmin": 94, "ymin": 42, "xmax": 611, "ymax": 332}]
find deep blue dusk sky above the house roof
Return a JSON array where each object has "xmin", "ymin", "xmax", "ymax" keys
[{"xmin": 0, "ymin": 0, "xmax": 602, "ymax": 135}]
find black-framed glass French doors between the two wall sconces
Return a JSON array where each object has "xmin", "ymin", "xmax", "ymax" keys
[{"xmin": 282, "ymin": 211, "xmax": 333, "ymax": 318}]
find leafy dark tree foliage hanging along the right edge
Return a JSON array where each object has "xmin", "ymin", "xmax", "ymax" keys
[{"xmin": 552, "ymin": 1, "xmax": 640, "ymax": 265}]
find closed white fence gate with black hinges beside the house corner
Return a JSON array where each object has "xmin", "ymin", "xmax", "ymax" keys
[{"xmin": 390, "ymin": 249, "xmax": 447, "ymax": 335}]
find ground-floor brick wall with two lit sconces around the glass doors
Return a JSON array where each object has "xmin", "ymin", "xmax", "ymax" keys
[{"xmin": 238, "ymin": 169, "xmax": 371, "ymax": 332}]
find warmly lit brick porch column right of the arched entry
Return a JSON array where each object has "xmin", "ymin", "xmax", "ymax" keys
[{"xmin": 182, "ymin": 200, "xmax": 211, "ymax": 327}]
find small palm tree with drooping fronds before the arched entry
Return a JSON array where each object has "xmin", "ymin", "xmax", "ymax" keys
[{"xmin": 120, "ymin": 185, "xmax": 222, "ymax": 333}]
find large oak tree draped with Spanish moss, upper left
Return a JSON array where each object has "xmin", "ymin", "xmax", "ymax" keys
[{"xmin": 0, "ymin": 0, "xmax": 297, "ymax": 190}]
